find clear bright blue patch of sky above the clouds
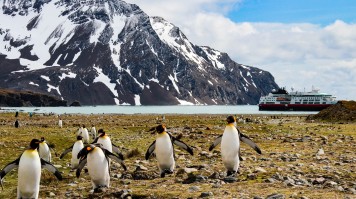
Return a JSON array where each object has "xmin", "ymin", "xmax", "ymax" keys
[{"xmin": 227, "ymin": 0, "xmax": 356, "ymax": 26}]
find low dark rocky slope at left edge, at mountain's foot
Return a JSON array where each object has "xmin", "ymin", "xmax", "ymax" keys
[{"xmin": 0, "ymin": 89, "xmax": 67, "ymax": 107}]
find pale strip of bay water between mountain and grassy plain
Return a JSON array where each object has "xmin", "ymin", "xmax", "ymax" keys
[{"xmin": 0, "ymin": 105, "xmax": 318, "ymax": 115}]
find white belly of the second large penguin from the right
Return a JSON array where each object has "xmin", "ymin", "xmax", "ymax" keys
[{"xmin": 155, "ymin": 133, "xmax": 175, "ymax": 171}]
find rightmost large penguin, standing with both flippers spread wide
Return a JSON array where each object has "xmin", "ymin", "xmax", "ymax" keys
[{"xmin": 209, "ymin": 116, "xmax": 262, "ymax": 176}]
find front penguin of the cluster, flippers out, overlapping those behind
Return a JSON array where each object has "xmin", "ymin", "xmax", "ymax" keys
[{"xmin": 76, "ymin": 143, "xmax": 127, "ymax": 192}]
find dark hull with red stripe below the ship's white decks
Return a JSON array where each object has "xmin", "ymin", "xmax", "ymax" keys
[{"xmin": 258, "ymin": 104, "xmax": 332, "ymax": 111}]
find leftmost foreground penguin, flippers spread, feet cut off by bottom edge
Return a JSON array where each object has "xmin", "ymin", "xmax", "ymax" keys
[{"xmin": 0, "ymin": 139, "xmax": 62, "ymax": 199}]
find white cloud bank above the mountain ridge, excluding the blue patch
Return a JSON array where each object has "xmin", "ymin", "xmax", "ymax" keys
[{"xmin": 127, "ymin": 0, "xmax": 356, "ymax": 100}]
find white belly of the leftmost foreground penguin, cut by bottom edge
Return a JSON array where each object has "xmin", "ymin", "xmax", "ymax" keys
[{"xmin": 17, "ymin": 150, "xmax": 41, "ymax": 198}]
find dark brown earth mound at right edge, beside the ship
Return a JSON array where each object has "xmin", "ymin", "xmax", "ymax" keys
[{"xmin": 307, "ymin": 101, "xmax": 356, "ymax": 122}]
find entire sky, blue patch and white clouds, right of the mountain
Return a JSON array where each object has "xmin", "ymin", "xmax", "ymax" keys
[{"xmin": 126, "ymin": 0, "xmax": 356, "ymax": 100}]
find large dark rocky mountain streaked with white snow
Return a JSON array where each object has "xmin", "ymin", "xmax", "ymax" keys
[{"xmin": 0, "ymin": 0, "xmax": 278, "ymax": 105}]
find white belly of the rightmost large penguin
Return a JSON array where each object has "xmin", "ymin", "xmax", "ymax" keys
[{"xmin": 221, "ymin": 126, "xmax": 240, "ymax": 171}]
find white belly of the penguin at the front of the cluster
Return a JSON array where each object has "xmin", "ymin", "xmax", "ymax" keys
[{"xmin": 87, "ymin": 147, "xmax": 110, "ymax": 189}]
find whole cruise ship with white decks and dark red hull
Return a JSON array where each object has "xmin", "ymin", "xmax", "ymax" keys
[{"xmin": 258, "ymin": 88, "xmax": 337, "ymax": 111}]
